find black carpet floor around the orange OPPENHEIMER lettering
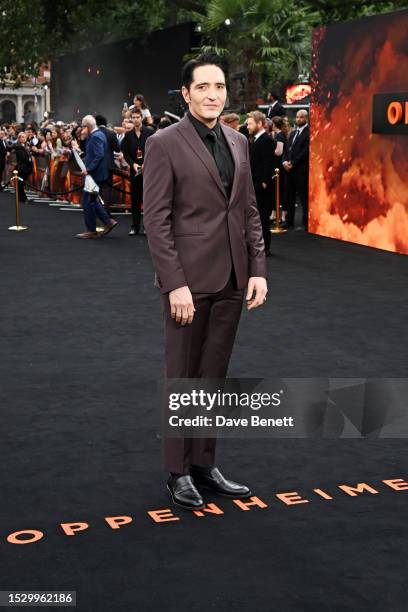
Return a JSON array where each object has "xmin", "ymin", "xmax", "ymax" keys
[{"xmin": 0, "ymin": 194, "xmax": 408, "ymax": 612}]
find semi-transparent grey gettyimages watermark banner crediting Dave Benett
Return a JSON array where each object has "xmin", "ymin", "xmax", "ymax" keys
[{"xmin": 161, "ymin": 378, "xmax": 408, "ymax": 438}]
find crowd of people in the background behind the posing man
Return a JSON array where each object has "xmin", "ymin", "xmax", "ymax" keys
[{"xmin": 0, "ymin": 92, "xmax": 309, "ymax": 243}]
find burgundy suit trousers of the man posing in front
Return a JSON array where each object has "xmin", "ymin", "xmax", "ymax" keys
[{"xmin": 162, "ymin": 273, "xmax": 244, "ymax": 474}]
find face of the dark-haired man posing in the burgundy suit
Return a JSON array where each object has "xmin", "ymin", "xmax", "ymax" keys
[{"xmin": 181, "ymin": 64, "xmax": 227, "ymax": 123}]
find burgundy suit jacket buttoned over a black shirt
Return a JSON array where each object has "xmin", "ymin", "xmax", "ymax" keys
[{"xmin": 143, "ymin": 116, "xmax": 266, "ymax": 293}]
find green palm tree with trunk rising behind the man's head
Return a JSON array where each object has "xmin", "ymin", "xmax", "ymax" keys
[{"xmin": 198, "ymin": 0, "xmax": 317, "ymax": 111}]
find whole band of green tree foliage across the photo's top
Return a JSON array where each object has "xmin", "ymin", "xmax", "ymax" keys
[{"xmin": 0, "ymin": 0, "xmax": 408, "ymax": 88}]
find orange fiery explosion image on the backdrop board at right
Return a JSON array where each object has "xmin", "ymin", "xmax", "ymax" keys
[{"xmin": 309, "ymin": 11, "xmax": 408, "ymax": 254}]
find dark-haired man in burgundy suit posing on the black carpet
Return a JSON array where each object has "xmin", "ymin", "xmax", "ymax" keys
[{"xmin": 143, "ymin": 54, "xmax": 267, "ymax": 510}]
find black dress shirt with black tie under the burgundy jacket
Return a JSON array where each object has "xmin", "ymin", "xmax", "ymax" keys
[{"xmin": 187, "ymin": 111, "xmax": 235, "ymax": 198}]
